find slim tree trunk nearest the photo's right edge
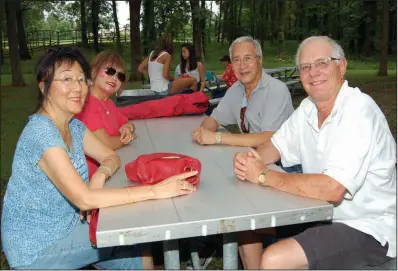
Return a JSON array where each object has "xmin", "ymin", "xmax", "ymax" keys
[{"xmin": 377, "ymin": 0, "xmax": 390, "ymax": 76}]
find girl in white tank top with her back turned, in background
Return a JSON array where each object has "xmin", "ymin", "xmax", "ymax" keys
[{"xmin": 138, "ymin": 34, "xmax": 196, "ymax": 95}]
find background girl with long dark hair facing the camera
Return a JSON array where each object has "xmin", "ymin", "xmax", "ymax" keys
[{"xmin": 175, "ymin": 43, "xmax": 206, "ymax": 91}]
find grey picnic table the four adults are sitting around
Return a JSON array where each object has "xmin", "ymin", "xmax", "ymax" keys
[{"xmin": 97, "ymin": 115, "xmax": 333, "ymax": 269}]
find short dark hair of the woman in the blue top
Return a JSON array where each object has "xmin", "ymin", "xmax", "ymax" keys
[{"xmin": 35, "ymin": 46, "xmax": 91, "ymax": 111}]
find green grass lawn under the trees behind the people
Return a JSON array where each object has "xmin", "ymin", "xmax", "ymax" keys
[{"xmin": 0, "ymin": 42, "xmax": 397, "ymax": 269}]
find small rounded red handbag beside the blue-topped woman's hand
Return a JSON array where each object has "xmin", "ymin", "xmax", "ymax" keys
[{"xmin": 125, "ymin": 153, "xmax": 202, "ymax": 185}]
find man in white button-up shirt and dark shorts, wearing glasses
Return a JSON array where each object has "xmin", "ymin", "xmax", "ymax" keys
[{"xmin": 234, "ymin": 36, "xmax": 397, "ymax": 269}]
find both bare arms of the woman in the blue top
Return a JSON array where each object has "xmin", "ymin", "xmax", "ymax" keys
[{"xmin": 38, "ymin": 131, "xmax": 197, "ymax": 211}]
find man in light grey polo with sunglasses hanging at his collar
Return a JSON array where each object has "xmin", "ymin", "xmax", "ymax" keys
[{"xmin": 192, "ymin": 36, "xmax": 293, "ymax": 147}]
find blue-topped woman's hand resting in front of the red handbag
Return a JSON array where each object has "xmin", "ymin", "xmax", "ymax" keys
[{"xmin": 152, "ymin": 171, "xmax": 198, "ymax": 199}]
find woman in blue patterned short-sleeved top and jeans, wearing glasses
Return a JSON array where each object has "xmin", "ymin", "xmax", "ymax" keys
[{"xmin": 1, "ymin": 47, "xmax": 196, "ymax": 269}]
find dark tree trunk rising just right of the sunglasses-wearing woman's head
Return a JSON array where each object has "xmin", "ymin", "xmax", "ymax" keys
[{"xmin": 129, "ymin": 0, "xmax": 142, "ymax": 82}]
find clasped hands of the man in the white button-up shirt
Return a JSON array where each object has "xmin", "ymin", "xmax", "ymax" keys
[{"xmin": 234, "ymin": 148, "xmax": 267, "ymax": 184}]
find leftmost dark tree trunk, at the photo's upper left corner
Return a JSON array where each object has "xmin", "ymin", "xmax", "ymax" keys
[{"xmin": 5, "ymin": 0, "xmax": 26, "ymax": 86}]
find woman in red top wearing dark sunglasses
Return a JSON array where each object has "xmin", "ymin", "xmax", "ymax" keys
[{"xmin": 76, "ymin": 50, "xmax": 136, "ymax": 179}]
